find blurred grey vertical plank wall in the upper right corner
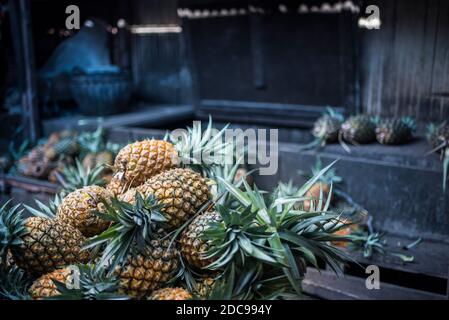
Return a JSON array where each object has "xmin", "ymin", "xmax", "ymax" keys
[{"xmin": 360, "ymin": 0, "xmax": 449, "ymax": 121}]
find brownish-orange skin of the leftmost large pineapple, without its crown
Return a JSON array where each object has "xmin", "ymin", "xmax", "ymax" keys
[{"xmin": 11, "ymin": 217, "xmax": 89, "ymax": 276}]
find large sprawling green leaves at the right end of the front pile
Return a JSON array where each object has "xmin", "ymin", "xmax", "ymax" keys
[{"xmin": 205, "ymin": 163, "xmax": 351, "ymax": 294}]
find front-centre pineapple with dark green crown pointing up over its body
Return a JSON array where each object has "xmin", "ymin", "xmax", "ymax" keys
[{"xmin": 87, "ymin": 193, "xmax": 180, "ymax": 298}]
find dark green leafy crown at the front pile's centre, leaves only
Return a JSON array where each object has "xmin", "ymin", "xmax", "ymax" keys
[{"xmin": 85, "ymin": 192, "xmax": 167, "ymax": 271}]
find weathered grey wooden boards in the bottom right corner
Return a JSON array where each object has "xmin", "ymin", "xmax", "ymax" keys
[{"xmin": 303, "ymin": 236, "xmax": 449, "ymax": 300}]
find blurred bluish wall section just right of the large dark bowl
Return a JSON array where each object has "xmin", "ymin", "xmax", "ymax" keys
[{"xmin": 132, "ymin": 0, "xmax": 191, "ymax": 103}]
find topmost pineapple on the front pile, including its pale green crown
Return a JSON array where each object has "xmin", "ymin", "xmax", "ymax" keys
[{"xmin": 110, "ymin": 121, "xmax": 225, "ymax": 187}]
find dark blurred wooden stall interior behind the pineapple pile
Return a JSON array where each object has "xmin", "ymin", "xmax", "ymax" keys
[{"xmin": 0, "ymin": 0, "xmax": 449, "ymax": 299}]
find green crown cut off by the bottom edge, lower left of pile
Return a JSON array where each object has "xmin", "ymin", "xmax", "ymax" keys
[{"xmin": 47, "ymin": 264, "xmax": 129, "ymax": 300}]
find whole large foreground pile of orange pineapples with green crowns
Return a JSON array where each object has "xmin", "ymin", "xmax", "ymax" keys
[{"xmin": 0, "ymin": 122, "xmax": 351, "ymax": 300}]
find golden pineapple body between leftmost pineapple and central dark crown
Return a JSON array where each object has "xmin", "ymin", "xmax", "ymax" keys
[{"xmin": 56, "ymin": 186, "xmax": 112, "ymax": 237}]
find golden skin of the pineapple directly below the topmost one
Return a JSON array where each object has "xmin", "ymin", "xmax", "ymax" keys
[{"xmin": 120, "ymin": 168, "xmax": 211, "ymax": 228}]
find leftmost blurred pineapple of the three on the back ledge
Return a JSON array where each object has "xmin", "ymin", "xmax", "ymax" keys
[{"xmin": 312, "ymin": 108, "xmax": 344, "ymax": 143}]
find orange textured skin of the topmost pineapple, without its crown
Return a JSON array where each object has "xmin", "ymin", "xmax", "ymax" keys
[{"xmin": 114, "ymin": 140, "xmax": 179, "ymax": 187}]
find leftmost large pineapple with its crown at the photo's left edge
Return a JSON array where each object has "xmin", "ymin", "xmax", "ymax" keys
[{"xmin": 0, "ymin": 202, "xmax": 89, "ymax": 275}]
